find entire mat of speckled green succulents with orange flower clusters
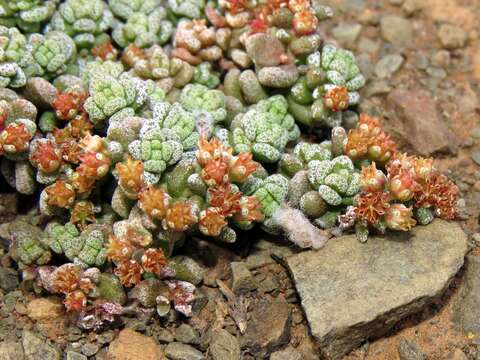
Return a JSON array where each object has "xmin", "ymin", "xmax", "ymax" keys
[{"xmin": 0, "ymin": 0, "xmax": 460, "ymax": 331}]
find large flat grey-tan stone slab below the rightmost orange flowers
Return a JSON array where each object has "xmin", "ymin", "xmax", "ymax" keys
[{"xmin": 287, "ymin": 220, "xmax": 466, "ymax": 360}]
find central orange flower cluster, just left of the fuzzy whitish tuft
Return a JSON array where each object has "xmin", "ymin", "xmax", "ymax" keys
[{"xmin": 197, "ymin": 138, "xmax": 264, "ymax": 236}]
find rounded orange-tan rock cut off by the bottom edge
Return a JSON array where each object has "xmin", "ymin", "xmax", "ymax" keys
[{"xmin": 107, "ymin": 329, "xmax": 165, "ymax": 360}]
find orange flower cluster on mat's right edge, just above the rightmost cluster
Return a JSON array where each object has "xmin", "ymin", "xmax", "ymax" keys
[{"xmin": 344, "ymin": 114, "xmax": 397, "ymax": 164}]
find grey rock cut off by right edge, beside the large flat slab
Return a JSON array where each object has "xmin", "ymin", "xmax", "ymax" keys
[{"xmin": 452, "ymin": 256, "xmax": 480, "ymax": 339}]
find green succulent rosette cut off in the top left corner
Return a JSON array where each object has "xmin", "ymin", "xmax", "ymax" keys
[{"xmin": 0, "ymin": 0, "xmax": 58, "ymax": 33}]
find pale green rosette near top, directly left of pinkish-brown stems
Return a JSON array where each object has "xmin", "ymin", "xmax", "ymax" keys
[{"xmin": 112, "ymin": 7, "xmax": 173, "ymax": 48}]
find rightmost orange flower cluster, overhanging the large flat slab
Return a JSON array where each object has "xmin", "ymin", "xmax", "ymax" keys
[{"xmin": 355, "ymin": 141, "xmax": 460, "ymax": 231}]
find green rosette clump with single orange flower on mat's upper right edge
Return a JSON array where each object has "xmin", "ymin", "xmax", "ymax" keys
[{"xmin": 289, "ymin": 44, "xmax": 365, "ymax": 127}]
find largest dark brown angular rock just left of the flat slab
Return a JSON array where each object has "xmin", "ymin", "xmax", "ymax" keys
[{"xmin": 241, "ymin": 297, "xmax": 291, "ymax": 358}]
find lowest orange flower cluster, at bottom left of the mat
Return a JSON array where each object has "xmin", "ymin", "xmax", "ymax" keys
[{"xmin": 51, "ymin": 263, "xmax": 95, "ymax": 312}]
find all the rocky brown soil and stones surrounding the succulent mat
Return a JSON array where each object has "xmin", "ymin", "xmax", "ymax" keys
[{"xmin": 0, "ymin": 0, "xmax": 480, "ymax": 360}]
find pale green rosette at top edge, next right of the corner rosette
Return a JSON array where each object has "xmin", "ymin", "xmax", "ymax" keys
[{"xmin": 50, "ymin": 0, "xmax": 113, "ymax": 48}]
